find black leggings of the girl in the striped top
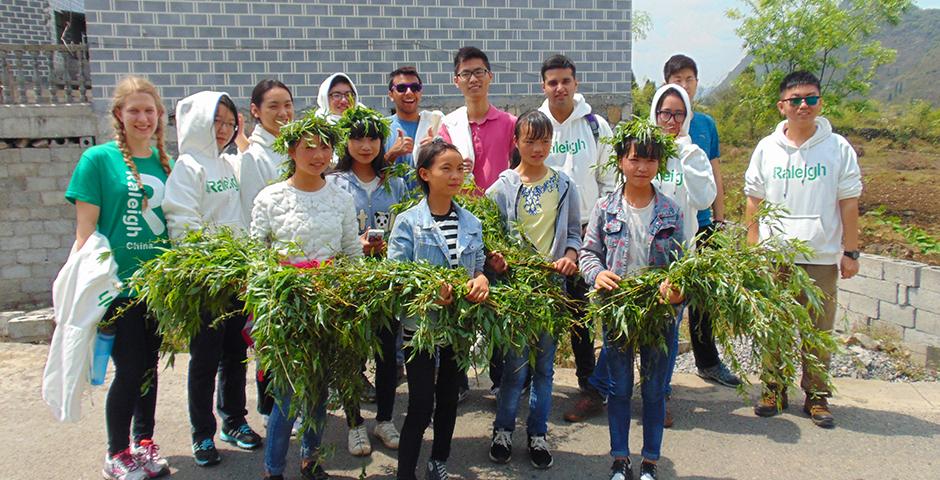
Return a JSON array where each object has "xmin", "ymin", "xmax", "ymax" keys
[{"xmin": 390, "ymin": 346, "xmax": 459, "ymax": 480}]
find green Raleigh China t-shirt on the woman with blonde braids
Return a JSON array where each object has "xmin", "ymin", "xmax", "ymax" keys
[{"xmin": 65, "ymin": 142, "xmax": 169, "ymax": 297}]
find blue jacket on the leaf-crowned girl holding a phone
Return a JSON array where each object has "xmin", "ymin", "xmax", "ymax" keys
[{"xmin": 326, "ymin": 170, "xmax": 407, "ymax": 235}]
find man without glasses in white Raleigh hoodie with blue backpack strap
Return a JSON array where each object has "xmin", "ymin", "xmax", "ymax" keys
[{"xmin": 539, "ymin": 55, "xmax": 617, "ymax": 404}]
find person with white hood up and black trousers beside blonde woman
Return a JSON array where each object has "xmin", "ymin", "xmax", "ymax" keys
[{"xmin": 163, "ymin": 91, "xmax": 261, "ymax": 466}]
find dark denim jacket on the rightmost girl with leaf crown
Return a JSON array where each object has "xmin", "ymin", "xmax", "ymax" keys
[{"xmin": 579, "ymin": 187, "xmax": 683, "ymax": 285}]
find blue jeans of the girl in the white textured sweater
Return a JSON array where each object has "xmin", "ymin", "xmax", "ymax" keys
[{"xmin": 264, "ymin": 389, "xmax": 327, "ymax": 475}]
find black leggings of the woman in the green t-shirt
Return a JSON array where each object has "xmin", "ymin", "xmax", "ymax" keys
[{"xmin": 104, "ymin": 298, "xmax": 161, "ymax": 455}]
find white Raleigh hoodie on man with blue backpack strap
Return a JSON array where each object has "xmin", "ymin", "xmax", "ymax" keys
[{"xmin": 539, "ymin": 93, "xmax": 617, "ymax": 225}]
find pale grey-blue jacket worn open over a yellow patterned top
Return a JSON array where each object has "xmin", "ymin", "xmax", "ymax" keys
[{"xmin": 486, "ymin": 170, "xmax": 581, "ymax": 261}]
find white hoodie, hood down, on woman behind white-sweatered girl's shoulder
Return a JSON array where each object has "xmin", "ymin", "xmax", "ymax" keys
[{"xmin": 239, "ymin": 123, "xmax": 289, "ymax": 225}]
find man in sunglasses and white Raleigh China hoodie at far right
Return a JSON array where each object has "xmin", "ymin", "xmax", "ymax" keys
[{"xmin": 744, "ymin": 72, "xmax": 862, "ymax": 428}]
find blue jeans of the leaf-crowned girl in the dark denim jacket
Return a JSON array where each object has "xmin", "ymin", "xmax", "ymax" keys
[{"xmin": 595, "ymin": 318, "xmax": 675, "ymax": 461}]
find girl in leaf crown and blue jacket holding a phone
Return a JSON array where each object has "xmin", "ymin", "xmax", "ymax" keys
[{"xmin": 327, "ymin": 105, "xmax": 407, "ymax": 456}]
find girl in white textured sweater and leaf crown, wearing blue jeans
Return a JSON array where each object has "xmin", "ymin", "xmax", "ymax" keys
[{"xmin": 250, "ymin": 113, "xmax": 363, "ymax": 479}]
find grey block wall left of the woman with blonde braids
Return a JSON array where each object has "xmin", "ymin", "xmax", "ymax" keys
[{"xmin": 0, "ymin": 104, "xmax": 97, "ymax": 309}]
